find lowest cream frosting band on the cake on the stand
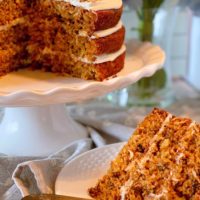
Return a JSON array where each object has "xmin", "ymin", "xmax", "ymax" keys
[{"xmin": 78, "ymin": 45, "xmax": 126, "ymax": 64}]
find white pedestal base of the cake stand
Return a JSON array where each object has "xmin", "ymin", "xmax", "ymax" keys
[{"xmin": 0, "ymin": 104, "xmax": 88, "ymax": 156}]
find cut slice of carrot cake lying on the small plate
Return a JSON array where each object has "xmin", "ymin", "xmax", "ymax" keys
[{"xmin": 89, "ymin": 109, "xmax": 200, "ymax": 200}]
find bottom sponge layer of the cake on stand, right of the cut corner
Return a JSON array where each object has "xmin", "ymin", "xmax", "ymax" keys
[{"xmin": 30, "ymin": 51, "xmax": 125, "ymax": 81}]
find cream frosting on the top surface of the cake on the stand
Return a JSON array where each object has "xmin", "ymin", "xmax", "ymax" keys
[{"xmin": 59, "ymin": 0, "xmax": 122, "ymax": 11}]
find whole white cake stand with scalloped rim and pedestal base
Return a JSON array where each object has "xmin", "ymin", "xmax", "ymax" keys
[{"xmin": 0, "ymin": 43, "xmax": 165, "ymax": 156}]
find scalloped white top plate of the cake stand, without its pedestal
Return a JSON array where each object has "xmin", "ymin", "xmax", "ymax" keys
[{"xmin": 0, "ymin": 42, "xmax": 165, "ymax": 106}]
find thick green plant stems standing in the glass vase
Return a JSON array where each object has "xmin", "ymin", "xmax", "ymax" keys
[{"xmin": 135, "ymin": 0, "xmax": 167, "ymax": 98}]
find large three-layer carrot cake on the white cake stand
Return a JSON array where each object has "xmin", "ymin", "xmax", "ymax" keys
[{"xmin": 0, "ymin": 0, "xmax": 126, "ymax": 81}]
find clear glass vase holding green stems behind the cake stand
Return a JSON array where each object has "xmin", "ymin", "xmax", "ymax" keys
[{"xmin": 107, "ymin": 5, "xmax": 177, "ymax": 107}]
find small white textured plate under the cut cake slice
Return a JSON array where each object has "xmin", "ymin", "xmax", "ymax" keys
[{"xmin": 55, "ymin": 143, "xmax": 125, "ymax": 199}]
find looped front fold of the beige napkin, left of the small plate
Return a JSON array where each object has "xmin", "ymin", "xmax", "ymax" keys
[{"xmin": 10, "ymin": 138, "xmax": 92, "ymax": 200}]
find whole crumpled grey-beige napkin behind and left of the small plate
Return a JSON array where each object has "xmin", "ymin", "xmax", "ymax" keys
[{"xmin": 9, "ymin": 109, "xmax": 134, "ymax": 200}]
